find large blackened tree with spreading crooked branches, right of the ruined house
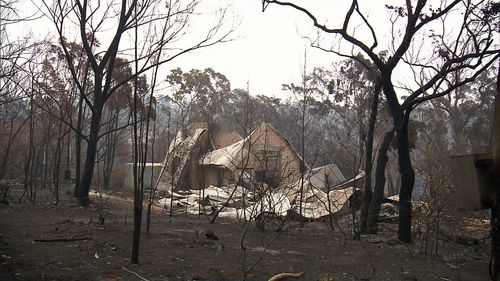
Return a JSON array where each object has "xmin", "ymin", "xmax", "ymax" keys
[{"xmin": 262, "ymin": 0, "xmax": 500, "ymax": 243}]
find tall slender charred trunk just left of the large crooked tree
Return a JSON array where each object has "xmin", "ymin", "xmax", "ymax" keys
[{"xmin": 360, "ymin": 82, "xmax": 381, "ymax": 233}]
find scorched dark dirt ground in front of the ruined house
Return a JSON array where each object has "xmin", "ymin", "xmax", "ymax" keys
[{"xmin": 0, "ymin": 186, "xmax": 490, "ymax": 281}]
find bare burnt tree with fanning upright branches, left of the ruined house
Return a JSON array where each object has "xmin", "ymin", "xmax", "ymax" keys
[{"xmin": 43, "ymin": 0, "xmax": 231, "ymax": 205}]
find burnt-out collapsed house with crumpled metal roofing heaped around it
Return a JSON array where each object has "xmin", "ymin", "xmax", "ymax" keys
[{"xmin": 152, "ymin": 123, "xmax": 365, "ymax": 222}]
